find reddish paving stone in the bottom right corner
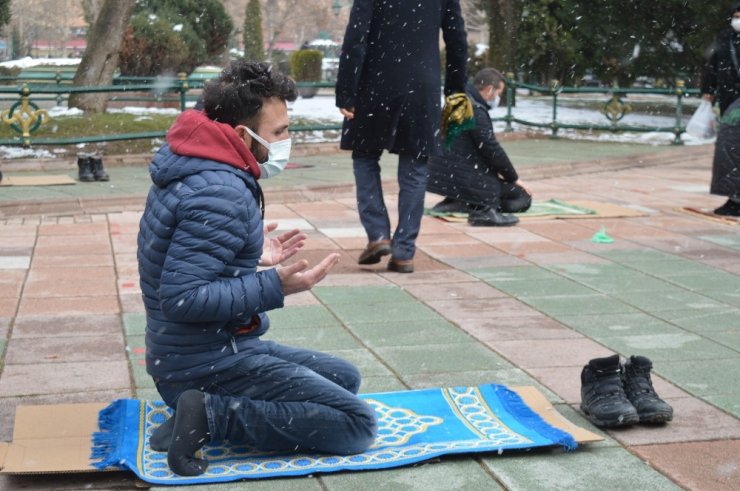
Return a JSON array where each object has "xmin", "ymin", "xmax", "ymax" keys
[{"xmin": 633, "ymin": 439, "xmax": 740, "ymax": 491}]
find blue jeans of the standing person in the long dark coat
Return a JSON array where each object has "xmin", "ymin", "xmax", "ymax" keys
[{"xmin": 352, "ymin": 152, "xmax": 428, "ymax": 260}]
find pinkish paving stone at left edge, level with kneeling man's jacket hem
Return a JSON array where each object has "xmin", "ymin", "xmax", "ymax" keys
[{"xmin": 0, "ymin": 360, "xmax": 130, "ymax": 397}]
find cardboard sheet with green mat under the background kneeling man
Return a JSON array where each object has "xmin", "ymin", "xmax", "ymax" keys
[{"xmin": 425, "ymin": 199, "xmax": 645, "ymax": 223}]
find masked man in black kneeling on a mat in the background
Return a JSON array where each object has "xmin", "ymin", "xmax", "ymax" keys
[{"xmin": 427, "ymin": 68, "xmax": 532, "ymax": 227}]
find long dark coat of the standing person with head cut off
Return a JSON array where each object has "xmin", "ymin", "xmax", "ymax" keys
[{"xmin": 336, "ymin": 0, "xmax": 467, "ymax": 158}]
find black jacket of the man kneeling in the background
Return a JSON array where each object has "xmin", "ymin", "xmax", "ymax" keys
[{"xmin": 427, "ymin": 85, "xmax": 519, "ymax": 204}]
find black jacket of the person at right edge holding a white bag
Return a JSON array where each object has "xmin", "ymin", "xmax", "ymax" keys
[{"xmin": 701, "ymin": 28, "xmax": 740, "ymax": 114}]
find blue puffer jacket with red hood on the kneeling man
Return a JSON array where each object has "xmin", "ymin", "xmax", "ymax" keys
[{"xmin": 137, "ymin": 111, "xmax": 284, "ymax": 382}]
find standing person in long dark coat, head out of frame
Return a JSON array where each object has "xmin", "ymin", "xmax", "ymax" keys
[{"xmin": 336, "ymin": 0, "xmax": 467, "ymax": 273}]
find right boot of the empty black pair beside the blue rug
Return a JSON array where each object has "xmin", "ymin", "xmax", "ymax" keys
[{"xmin": 623, "ymin": 356, "xmax": 673, "ymax": 423}]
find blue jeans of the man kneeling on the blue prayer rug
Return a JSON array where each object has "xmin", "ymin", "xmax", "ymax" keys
[{"xmin": 156, "ymin": 339, "xmax": 378, "ymax": 455}]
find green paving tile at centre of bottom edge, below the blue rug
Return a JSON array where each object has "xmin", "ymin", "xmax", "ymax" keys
[{"xmin": 321, "ymin": 456, "xmax": 502, "ymax": 491}]
